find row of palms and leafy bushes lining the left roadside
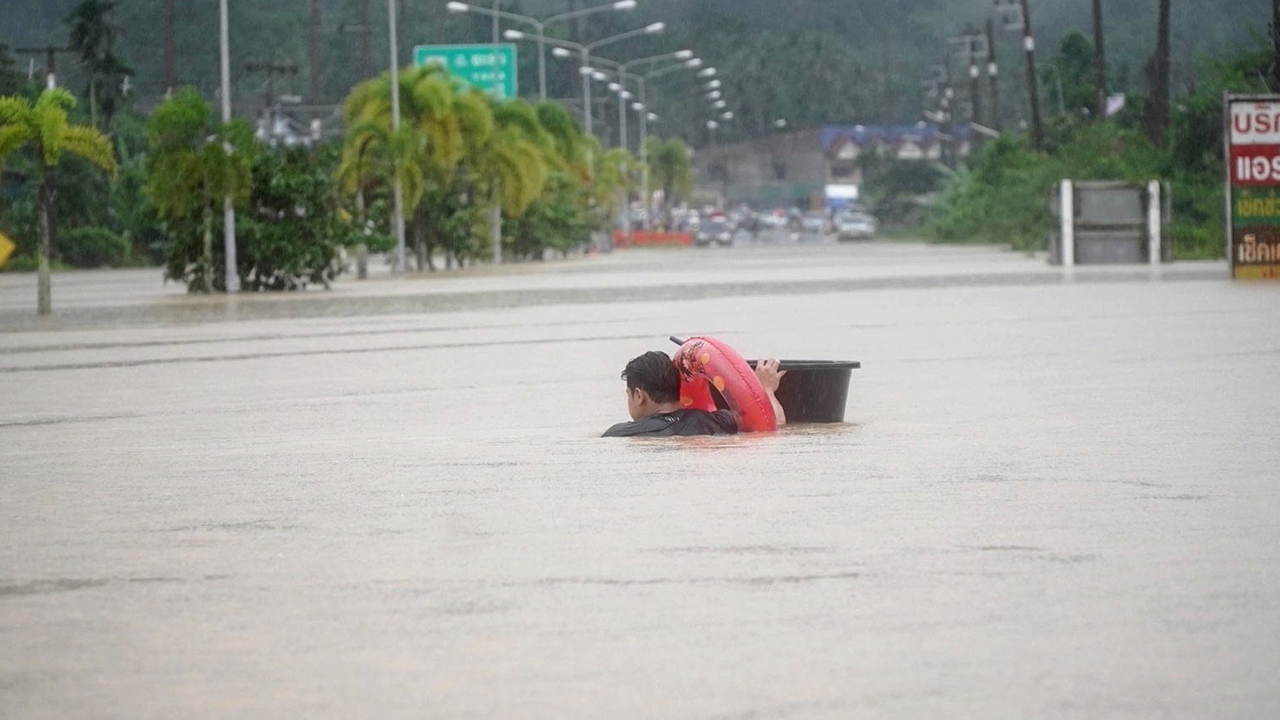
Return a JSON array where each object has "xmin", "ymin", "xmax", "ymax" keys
[{"xmin": 0, "ymin": 0, "xmax": 690, "ymax": 302}]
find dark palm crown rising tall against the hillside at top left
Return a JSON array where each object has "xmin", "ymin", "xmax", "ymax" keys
[{"xmin": 65, "ymin": 0, "xmax": 133, "ymax": 128}]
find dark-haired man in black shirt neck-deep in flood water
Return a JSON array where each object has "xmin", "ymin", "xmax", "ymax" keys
[{"xmin": 603, "ymin": 350, "xmax": 787, "ymax": 437}]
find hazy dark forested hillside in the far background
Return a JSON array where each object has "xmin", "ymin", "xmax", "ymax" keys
[{"xmin": 0, "ymin": 0, "xmax": 1271, "ymax": 143}]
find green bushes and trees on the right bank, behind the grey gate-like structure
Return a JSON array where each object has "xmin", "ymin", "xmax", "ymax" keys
[{"xmin": 922, "ymin": 33, "xmax": 1271, "ymax": 259}]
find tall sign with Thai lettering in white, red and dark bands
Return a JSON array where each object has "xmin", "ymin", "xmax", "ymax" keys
[{"xmin": 1224, "ymin": 95, "xmax": 1280, "ymax": 279}]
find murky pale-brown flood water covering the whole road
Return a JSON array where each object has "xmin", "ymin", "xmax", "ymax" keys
[{"xmin": 0, "ymin": 243, "xmax": 1280, "ymax": 720}]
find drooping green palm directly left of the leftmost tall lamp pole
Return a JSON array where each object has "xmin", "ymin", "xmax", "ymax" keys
[{"xmin": 147, "ymin": 88, "xmax": 257, "ymax": 292}]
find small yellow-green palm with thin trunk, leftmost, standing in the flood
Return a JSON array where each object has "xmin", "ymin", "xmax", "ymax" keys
[{"xmin": 0, "ymin": 88, "xmax": 115, "ymax": 315}]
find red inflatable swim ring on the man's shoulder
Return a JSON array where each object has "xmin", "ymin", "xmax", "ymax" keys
[{"xmin": 675, "ymin": 337, "xmax": 778, "ymax": 433}]
